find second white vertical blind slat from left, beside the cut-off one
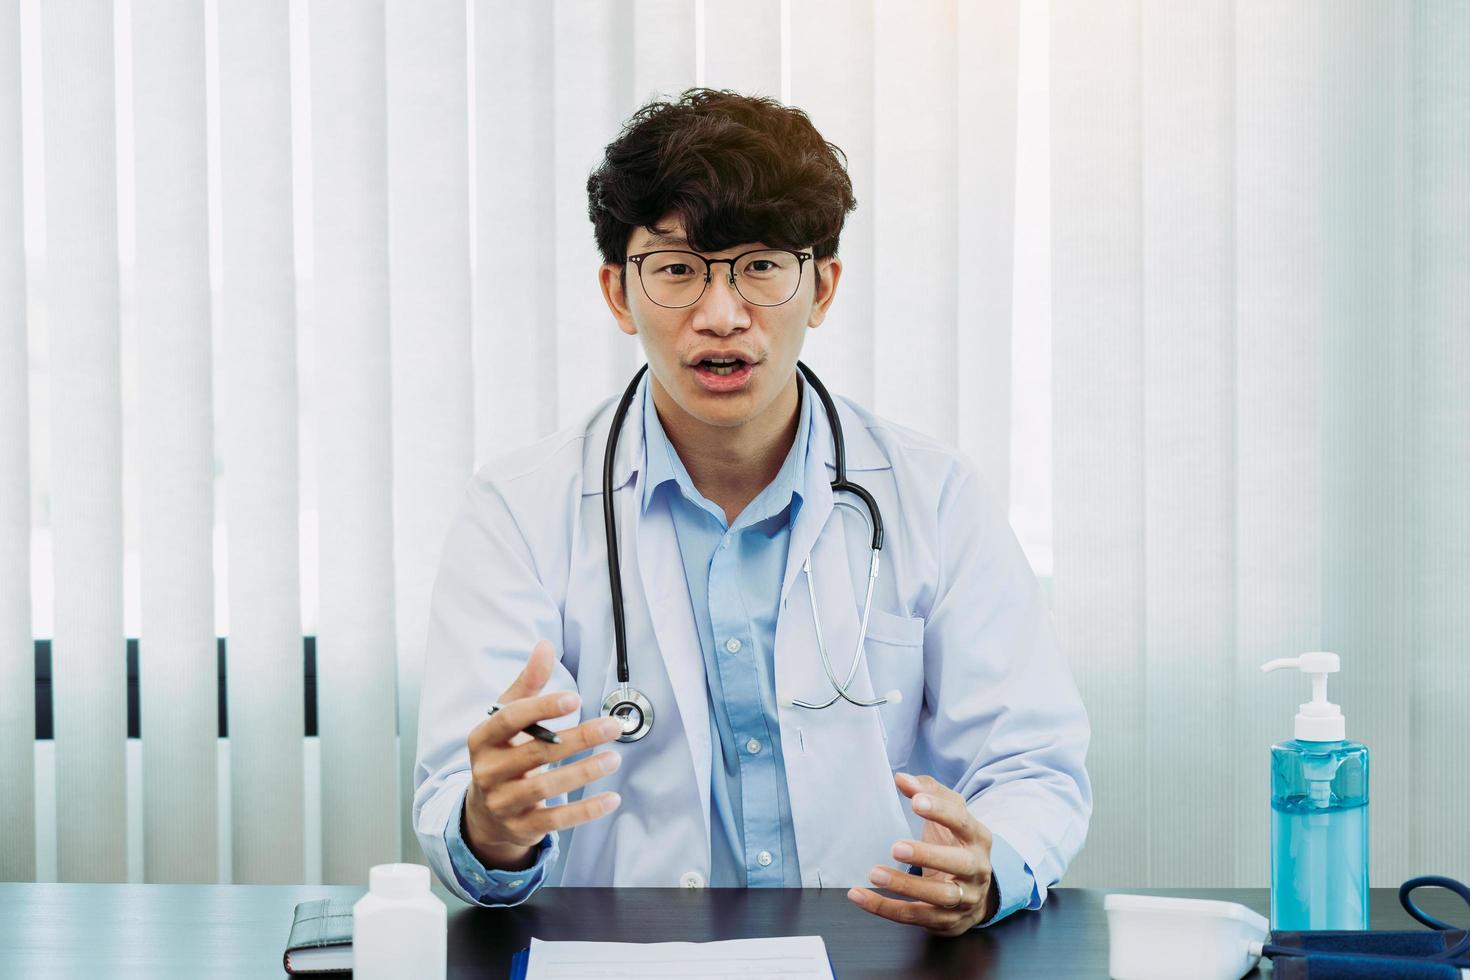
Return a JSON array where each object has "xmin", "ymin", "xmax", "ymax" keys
[{"xmin": 39, "ymin": 3, "xmax": 126, "ymax": 882}]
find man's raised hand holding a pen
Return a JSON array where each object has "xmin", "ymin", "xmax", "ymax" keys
[{"xmin": 465, "ymin": 639, "xmax": 622, "ymax": 871}]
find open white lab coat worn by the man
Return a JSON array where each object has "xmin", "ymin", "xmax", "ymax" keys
[{"xmin": 413, "ymin": 375, "xmax": 1092, "ymax": 901}]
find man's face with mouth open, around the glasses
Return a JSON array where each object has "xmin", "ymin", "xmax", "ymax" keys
[{"xmin": 600, "ymin": 215, "xmax": 842, "ymax": 426}]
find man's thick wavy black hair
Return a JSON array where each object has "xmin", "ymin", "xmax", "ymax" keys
[{"xmin": 587, "ymin": 88, "xmax": 857, "ymax": 302}]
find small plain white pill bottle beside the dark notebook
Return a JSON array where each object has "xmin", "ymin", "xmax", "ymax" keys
[{"xmin": 353, "ymin": 864, "xmax": 448, "ymax": 980}]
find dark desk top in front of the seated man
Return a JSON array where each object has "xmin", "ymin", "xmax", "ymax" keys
[{"xmin": 0, "ymin": 883, "xmax": 1466, "ymax": 980}]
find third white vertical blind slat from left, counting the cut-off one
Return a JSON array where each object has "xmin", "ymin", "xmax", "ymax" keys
[{"xmin": 133, "ymin": 0, "xmax": 219, "ymax": 882}]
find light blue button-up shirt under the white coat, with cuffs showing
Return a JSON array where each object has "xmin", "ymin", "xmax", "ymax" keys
[{"xmin": 444, "ymin": 382, "xmax": 1039, "ymax": 926}]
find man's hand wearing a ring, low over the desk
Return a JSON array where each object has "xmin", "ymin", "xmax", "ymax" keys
[{"xmin": 847, "ymin": 773, "xmax": 1000, "ymax": 936}]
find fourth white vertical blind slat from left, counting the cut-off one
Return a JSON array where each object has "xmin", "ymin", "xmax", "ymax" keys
[{"xmin": 216, "ymin": 0, "xmax": 306, "ymax": 883}]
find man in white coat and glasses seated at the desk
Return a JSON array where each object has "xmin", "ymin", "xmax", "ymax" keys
[{"xmin": 413, "ymin": 90, "xmax": 1092, "ymax": 934}]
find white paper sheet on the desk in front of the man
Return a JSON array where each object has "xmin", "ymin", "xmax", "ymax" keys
[{"xmin": 526, "ymin": 936, "xmax": 832, "ymax": 980}]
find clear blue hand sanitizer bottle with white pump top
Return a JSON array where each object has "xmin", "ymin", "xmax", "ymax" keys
[{"xmin": 1261, "ymin": 652, "xmax": 1369, "ymax": 932}]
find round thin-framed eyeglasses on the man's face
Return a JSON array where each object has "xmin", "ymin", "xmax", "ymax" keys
[{"xmin": 628, "ymin": 248, "xmax": 811, "ymax": 310}]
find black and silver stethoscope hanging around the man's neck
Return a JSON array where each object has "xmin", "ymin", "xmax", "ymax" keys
[{"xmin": 603, "ymin": 361, "xmax": 901, "ymax": 742}]
